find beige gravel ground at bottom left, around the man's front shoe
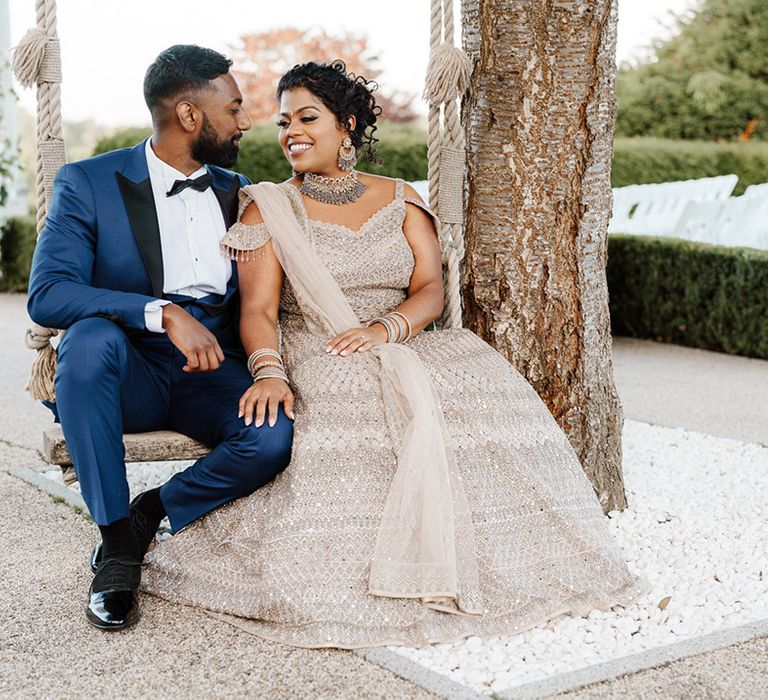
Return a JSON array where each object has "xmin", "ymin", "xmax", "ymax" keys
[{"xmin": 0, "ymin": 460, "xmax": 433, "ymax": 699}]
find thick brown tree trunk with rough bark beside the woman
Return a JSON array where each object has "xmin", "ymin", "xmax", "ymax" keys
[{"xmin": 462, "ymin": 0, "xmax": 626, "ymax": 512}]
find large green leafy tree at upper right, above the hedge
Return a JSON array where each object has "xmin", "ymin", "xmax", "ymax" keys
[{"xmin": 616, "ymin": 0, "xmax": 768, "ymax": 141}]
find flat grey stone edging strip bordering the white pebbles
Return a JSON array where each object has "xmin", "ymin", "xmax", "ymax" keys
[{"xmin": 10, "ymin": 467, "xmax": 768, "ymax": 700}]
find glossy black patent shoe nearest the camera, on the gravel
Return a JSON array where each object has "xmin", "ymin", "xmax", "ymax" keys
[{"xmin": 85, "ymin": 559, "xmax": 141, "ymax": 630}]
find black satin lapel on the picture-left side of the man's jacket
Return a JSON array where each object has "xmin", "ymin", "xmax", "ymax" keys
[{"xmin": 115, "ymin": 173, "xmax": 163, "ymax": 297}]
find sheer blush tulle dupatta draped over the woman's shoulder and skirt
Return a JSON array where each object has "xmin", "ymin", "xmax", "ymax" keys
[{"xmin": 246, "ymin": 183, "xmax": 482, "ymax": 615}]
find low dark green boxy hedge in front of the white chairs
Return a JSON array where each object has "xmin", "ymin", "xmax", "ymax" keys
[{"xmin": 608, "ymin": 235, "xmax": 768, "ymax": 359}]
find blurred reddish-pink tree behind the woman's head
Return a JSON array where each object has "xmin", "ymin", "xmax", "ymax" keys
[{"xmin": 233, "ymin": 27, "xmax": 416, "ymax": 122}]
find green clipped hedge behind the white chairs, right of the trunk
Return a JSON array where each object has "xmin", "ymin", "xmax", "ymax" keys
[{"xmin": 611, "ymin": 138, "xmax": 768, "ymax": 195}]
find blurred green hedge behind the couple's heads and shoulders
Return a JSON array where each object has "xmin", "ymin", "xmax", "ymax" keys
[{"xmin": 93, "ymin": 124, "xmax": 427, "ymax": 182}]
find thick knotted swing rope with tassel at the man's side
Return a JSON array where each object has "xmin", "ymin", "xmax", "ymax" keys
[{"xmin": 12, "ymin": 0, "xmax": 67, "ymax": 401}]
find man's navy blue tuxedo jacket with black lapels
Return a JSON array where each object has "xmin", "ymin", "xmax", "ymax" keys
[{"xmin": 28, "ymin": 142, "xmax": 249, "ymax": 330}]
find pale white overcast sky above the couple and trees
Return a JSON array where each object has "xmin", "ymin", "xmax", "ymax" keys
[{"xmin": 10, "ymin": 0, "xmax": 698, "ymax": 125}]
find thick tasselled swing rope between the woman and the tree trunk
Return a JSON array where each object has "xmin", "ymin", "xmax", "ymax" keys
[{"xmin": 424, "ymin": 0, "xmax": 472, "ymax": 328}]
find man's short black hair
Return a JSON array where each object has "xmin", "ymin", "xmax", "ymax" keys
[{"xmin": 144, "ymin": 44, "xmax": 232, "ymax": 115}]
